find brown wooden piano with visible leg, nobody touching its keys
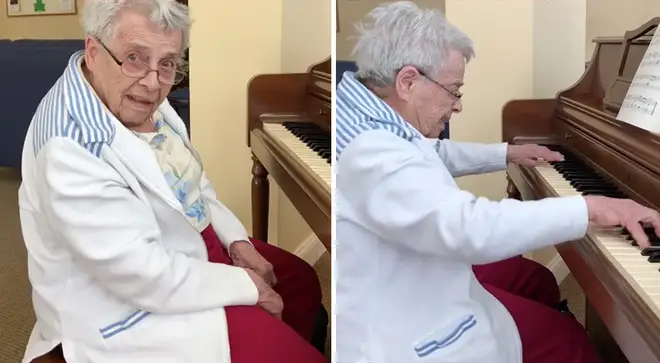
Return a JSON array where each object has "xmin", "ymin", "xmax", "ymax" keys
[{"xmin": 247, "ymin": 58, "xmax": 332, "ymax": 251}]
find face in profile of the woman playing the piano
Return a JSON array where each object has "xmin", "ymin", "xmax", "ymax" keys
[{"xmin": 396, "ymin": 50, "xmax": 465, "ymax": 138}]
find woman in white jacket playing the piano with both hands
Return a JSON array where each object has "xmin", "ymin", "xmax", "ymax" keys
[{"xmin": 335, "ymin": 2, "xmax": 660, "ymax": 363}]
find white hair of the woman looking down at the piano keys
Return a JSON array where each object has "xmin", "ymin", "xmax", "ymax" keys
[{"xmin": 353, "ymin": 1, "xmax": 474, "ymax": 87}]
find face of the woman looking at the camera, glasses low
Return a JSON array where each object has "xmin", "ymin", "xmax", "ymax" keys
[{"xmin": 85, "ymin": 10, "xmax": 183, "ymax": 128}]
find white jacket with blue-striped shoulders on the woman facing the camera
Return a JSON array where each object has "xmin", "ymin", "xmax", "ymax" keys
[{"xmin": 19, "ymin": 52, "xmax": 258, "ymax": 363}]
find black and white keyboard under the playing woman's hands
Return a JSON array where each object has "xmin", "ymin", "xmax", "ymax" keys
[{"xmin": 535, "ymin": 146, "xmax": 660, "ymax": 315}]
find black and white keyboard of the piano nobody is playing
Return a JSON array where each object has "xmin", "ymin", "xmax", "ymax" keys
[{"xmin": 264, "ymin": 122, "xmax": 332, "ymax": 193}]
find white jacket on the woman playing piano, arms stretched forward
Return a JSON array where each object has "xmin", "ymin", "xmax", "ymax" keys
[{"xmin": 335, "ymin": 74, "xmax": 588, "ymax": 363}]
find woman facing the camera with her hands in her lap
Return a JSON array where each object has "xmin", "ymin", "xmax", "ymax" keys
[{"xmin": 19, "ymin": 0, "xmax": 326, "ymax": 363}]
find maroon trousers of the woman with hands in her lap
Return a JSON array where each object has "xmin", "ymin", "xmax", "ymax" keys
[{"xmin": 202, "ymin": 226, "xmax": 327, "ymax": 363}]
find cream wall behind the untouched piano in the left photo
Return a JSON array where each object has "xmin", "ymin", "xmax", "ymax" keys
[{"xmin": 190, "ymin": 0, "xmax": 331, "ymax": 251}]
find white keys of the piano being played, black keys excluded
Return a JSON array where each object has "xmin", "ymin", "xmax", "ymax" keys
[{"xmin": 535, "ymin": 162, "xmax": 660, "ymax": 315}]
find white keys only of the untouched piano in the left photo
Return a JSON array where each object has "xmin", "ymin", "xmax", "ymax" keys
[{"xmin": 264, "ymin": 123, "xmax": 332, "ymax": 192}]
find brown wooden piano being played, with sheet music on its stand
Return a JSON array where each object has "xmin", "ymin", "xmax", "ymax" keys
[{"xmin": 502, "ymin": 18, "xmax": 660, "ymax": 363}]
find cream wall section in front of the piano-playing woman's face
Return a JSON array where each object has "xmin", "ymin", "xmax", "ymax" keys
[{"xmin": 445, "ymin": 0, "xmax": 534, "ymax": 199}]
